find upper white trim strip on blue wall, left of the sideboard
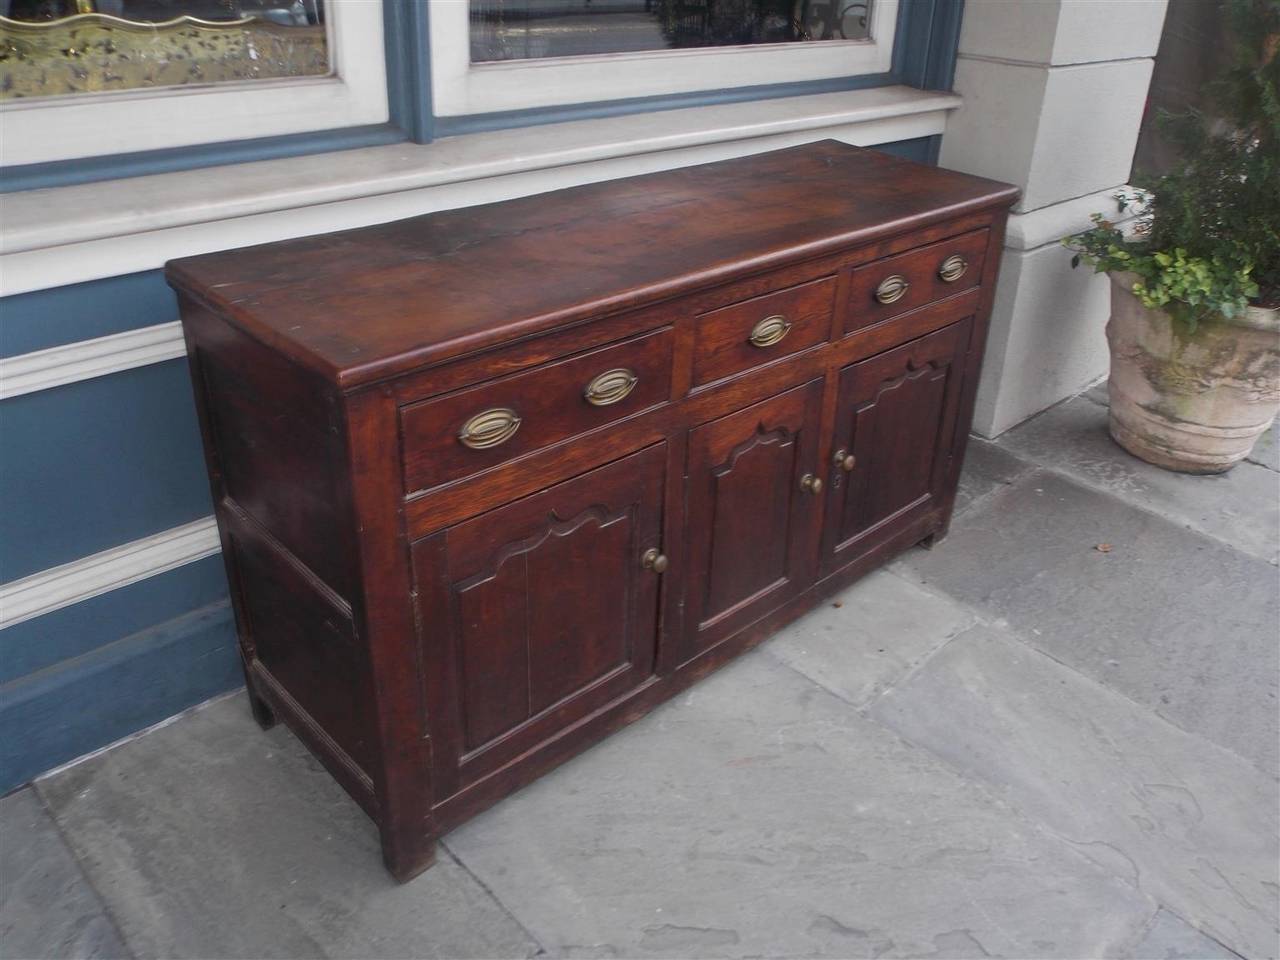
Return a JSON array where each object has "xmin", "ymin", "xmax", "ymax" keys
[{"xmin": 0, "ymin": 321, "xmax": 187, "ymax": 399}]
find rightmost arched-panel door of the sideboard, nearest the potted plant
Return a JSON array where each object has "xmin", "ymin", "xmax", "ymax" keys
[{"xmin": 823, "ymin": 320, "xmax": 972, "ymax": 570}]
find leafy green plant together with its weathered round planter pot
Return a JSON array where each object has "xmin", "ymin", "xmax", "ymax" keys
[{"xmin": 1064, "ymin": 0, "xmax": 1280, "ymax": 474}]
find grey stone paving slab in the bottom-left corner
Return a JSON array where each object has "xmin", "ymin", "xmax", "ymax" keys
[{"xmin": 0, "ymin": 788, "xmax": 129, "ymax": 960}]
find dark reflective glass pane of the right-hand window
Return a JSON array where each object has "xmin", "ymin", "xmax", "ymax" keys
[{"xmin": 471, "ymin": 0, "xmax": 873, "ymax": 63}]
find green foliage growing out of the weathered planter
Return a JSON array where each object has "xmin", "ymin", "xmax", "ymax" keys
[{"xmin": 1064, "ymin": 0, "xmax": 1280, "ymax": 329}]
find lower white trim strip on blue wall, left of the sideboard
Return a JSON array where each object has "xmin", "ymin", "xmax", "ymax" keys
[{"xmin": 0, "ymin": 517, "xmax": 221, "ymax": 630}]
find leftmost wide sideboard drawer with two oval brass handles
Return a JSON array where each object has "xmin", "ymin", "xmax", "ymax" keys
[{"xmin": 401, "ymin": 326, "xmax": 673, "ymax": 492}]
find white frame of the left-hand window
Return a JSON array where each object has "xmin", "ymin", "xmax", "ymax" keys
[{"xmin": 0, "ymin": 0, "xmax": 389, "ymax": 166}]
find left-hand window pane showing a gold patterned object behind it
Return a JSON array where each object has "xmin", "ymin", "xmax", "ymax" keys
[{"xmin": 0, "ymin": 0, "xmax": 329, "ymax": 100}]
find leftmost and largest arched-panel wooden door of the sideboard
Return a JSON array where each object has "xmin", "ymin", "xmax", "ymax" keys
[{"xmin": 413, "ymin": 443, "xmax": 666, "ymax": 803}]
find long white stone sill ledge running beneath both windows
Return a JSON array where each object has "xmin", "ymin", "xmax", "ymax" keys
[{"xmin": 0, "ymin": 86, "xmax": 961, "ymax": 263}]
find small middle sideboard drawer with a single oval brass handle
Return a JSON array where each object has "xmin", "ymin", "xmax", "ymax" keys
[{"xmin": 694, "ymin": 276, "xmax": 836, "ymax": 387}]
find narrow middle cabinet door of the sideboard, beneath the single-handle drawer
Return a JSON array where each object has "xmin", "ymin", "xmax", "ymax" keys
[{"xmin": 681, "ymin": 380, "xmax": 822, "ymax": 660}]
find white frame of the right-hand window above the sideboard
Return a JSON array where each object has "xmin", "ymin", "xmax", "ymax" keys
[{"xmin": 428, "ymin": 0, "xmax": 899, "ymax": 116}]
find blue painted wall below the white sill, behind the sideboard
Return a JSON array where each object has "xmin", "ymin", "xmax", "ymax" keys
[{"xmin": 0, "ymin": 137, "xmax": 937, "ymax": 792}]
